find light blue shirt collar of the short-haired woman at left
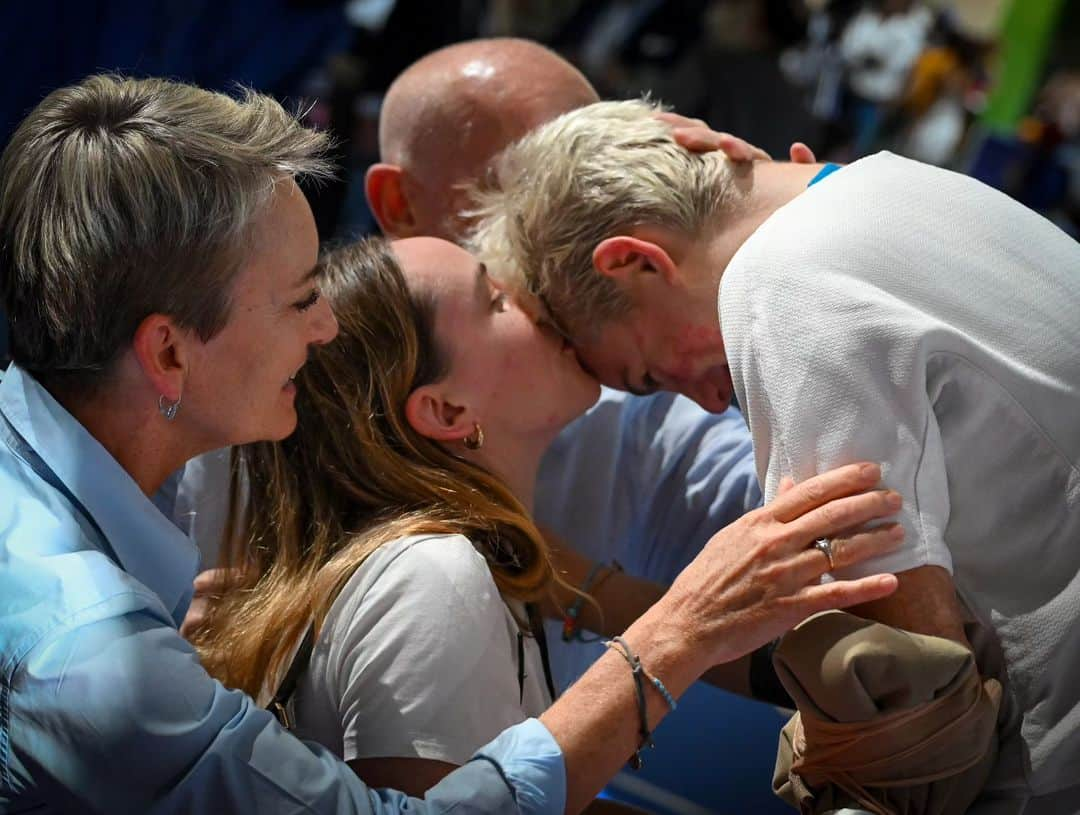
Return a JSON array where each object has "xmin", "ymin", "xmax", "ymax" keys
[{"xmin": 0, "ymin": 364, "xmax": 199, "ymax": 624}]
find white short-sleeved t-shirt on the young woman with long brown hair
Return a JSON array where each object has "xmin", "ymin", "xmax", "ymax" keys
[{"xmin": 291, "ymin": 534, "xmax": 551, "ymax": 764}]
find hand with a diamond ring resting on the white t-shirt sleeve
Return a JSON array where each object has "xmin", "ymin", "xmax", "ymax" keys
[{"xmin": 661, "ymin": 463, "xmax": 903, "ymax": 665}]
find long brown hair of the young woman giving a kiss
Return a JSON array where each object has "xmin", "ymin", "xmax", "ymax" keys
[{"xmin": 189, "ymin": 239, "xmax": 554, "ymax": 695}]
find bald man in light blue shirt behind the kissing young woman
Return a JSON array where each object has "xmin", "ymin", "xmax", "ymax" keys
[{"xmin": 366, "ymin": 39, "xmax": 813, "ymax": 702}]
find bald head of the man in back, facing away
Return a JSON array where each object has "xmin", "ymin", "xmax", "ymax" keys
[{"xmin": 367, "ymin": 39, "xmax": 598, "ymax": 240}]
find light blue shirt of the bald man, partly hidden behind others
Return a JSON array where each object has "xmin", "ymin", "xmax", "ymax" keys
[{"xmin": 170, "ymin": 388, "xmax": 761, "ymax": 689}]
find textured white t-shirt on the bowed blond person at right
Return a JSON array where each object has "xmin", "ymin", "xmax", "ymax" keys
[{"xmin": 719, "ymin": 153, "xmax": 1080, "ymax": 812}]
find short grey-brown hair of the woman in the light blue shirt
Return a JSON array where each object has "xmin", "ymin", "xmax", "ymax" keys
[{"xmin": 0, "ymin": 76, "xmax": 329, "ymax": 389}]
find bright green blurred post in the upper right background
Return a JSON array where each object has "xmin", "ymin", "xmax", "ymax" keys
[{"xmin": 983, "ymin": 0, "xmax": 1065, "ymax": 133}]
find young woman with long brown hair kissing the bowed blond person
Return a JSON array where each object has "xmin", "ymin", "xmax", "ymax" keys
[{"xmin": 198, "ymin": 239, "xmax": 895, "ymax": 792}]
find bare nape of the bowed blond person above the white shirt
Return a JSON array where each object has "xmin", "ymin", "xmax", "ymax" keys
[{"xmin": 702, "ymin": 161, "xmax": 824, "ymax": 286}]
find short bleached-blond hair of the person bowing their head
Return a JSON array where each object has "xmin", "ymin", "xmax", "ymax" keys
[{"xmin": 470, "ymin": 100, "xmax": 734, "ymax": 338}]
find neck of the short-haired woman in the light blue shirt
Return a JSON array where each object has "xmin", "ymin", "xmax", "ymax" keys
[{"xmin": 51, "ymin": 375, "xmax": 199, "ymax": 498}]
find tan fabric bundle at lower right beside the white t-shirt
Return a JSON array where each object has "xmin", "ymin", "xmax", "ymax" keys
[{"xmin": 772, "ymin": 611, "xmax": 1001, "ymax": 815}]
